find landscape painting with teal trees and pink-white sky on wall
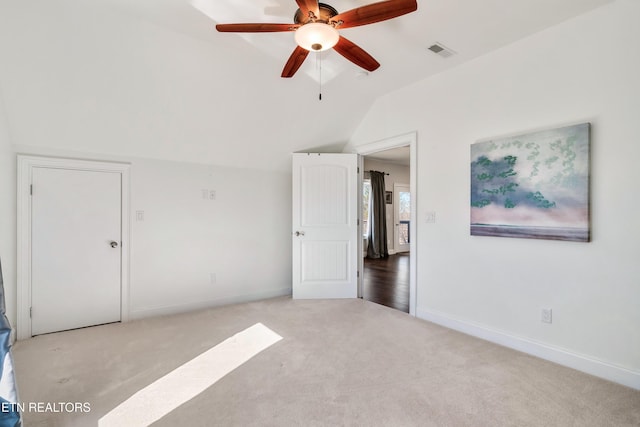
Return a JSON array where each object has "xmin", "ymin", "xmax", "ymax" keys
[{"xmin": 471, "ymin": 123, "xmax": 591, "ymax": 242}]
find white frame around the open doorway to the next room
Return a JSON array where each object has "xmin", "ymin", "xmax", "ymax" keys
[{"xmin": 354, "ymin": 132, "xmax": 418, "ymax": 316}]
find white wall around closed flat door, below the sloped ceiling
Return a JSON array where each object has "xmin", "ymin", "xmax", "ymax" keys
[{"xmin": 3, "ymin": 145, "xmax": 291, "ymax": 325}]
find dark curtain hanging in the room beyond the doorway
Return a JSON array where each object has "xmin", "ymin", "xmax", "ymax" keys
[{"xmin": 367, "ymin": 171, "xmax": 389, "ymax": 258}]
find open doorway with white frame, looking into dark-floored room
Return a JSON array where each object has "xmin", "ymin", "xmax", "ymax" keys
[{"xmin": 358, "ymin": 133, "xmax": 417, "ymax": 315}]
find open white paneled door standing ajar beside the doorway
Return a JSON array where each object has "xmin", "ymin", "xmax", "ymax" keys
[{"xmin": 292, "ymin": 153, "xmax": 359, "ymax": 299}]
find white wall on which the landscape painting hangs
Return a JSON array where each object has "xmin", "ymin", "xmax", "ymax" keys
[{"xmin": 350, "ymin": 0, "xmax": 640, "ymax": 388}]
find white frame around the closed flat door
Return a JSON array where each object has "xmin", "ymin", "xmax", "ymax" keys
[{"xmin": 16, "ymin": 154, "xmax": 131, "ymax": 340}]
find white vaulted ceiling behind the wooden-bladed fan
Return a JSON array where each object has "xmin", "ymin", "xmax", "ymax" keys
[{"xmin": 0, "ymin": 0, "xmax": 612, "ymax": 170}]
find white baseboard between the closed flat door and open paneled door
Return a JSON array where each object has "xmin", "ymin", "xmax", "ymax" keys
[{"xmin": 129, "ymin": 287, "xmax": 291, "ymax": 320}]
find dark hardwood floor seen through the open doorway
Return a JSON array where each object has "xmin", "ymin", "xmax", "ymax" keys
[{"xmin": 362, "ymin": 252, "xmax": 409, "ymax": 313}]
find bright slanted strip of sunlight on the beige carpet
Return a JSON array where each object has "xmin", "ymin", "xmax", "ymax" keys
[{"xmin": 98, "ymin": 323, "xmax": 282, "ymax": 427}]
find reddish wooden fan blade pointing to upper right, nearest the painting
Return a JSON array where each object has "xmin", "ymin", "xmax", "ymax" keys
[{"xmin": 331, "ymin": 0, "xmax": 418, "ymax": 29}]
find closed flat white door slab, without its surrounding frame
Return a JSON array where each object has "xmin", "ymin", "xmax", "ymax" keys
[{"xmin": 31, "ymin": 167, "xmax": 122, "ymax": 335}]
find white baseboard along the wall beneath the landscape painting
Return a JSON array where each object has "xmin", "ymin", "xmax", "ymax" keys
[{"xmin": 416, "ymin": 308, "xmax": 640, "ymax": 390}]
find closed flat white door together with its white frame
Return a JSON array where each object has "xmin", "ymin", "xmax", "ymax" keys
[{"xmin": 17, "ymin": 156, "xmax": 129, "ymax": 339}]
